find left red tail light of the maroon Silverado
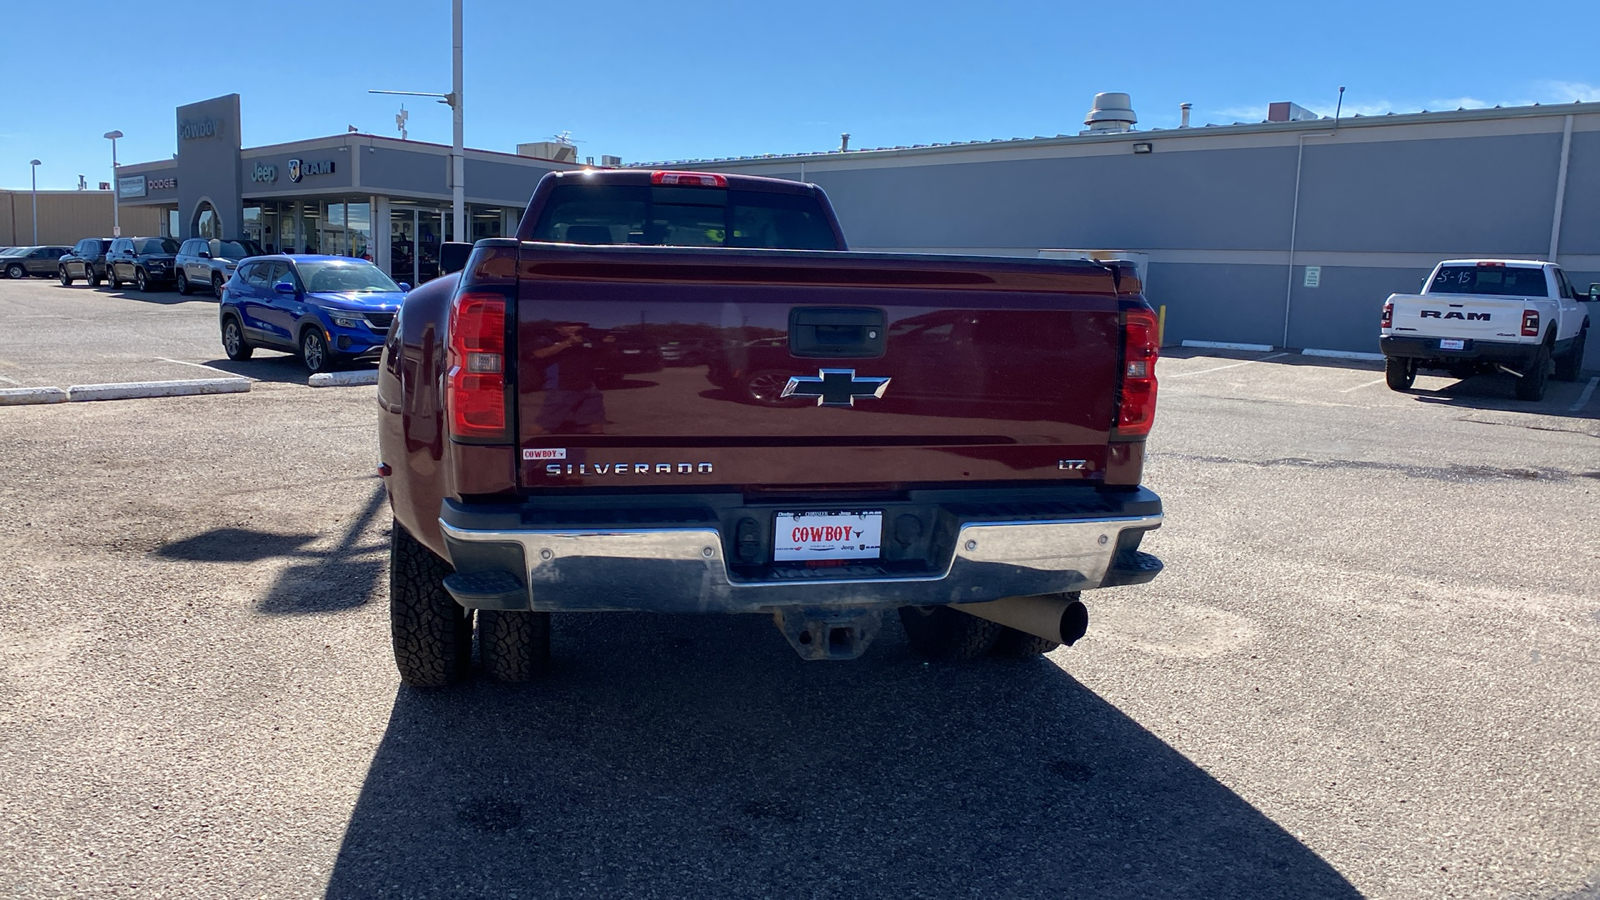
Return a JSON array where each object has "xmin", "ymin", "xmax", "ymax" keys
[{"xmin": 445, "ymin": 293, "xmax": 510, "ymax": 440}]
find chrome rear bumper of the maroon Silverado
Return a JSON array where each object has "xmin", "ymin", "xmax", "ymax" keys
[{"xmin": 440, "ymin": 516, "xmax": 1162, "ymax": 612}]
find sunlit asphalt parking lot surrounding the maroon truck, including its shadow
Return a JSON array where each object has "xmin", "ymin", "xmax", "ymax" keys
[{"xmin": 0, "ymin": 280, "xmax": 1600, "ymax": 898}]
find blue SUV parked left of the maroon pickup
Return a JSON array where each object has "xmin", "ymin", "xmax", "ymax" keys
[{"xmin": 219, "ymin": 256, "xmax": 411, "ymax": 373}]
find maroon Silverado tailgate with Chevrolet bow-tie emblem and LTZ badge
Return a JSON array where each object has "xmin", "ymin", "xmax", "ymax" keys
[{"xmin": 514, "ymin": 243, "xmax": 1120, "ymax": 490}]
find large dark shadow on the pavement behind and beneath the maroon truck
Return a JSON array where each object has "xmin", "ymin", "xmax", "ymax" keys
[{"xmin": 326, "ymin": 613, "xmax": 1358, "ymax": 898}]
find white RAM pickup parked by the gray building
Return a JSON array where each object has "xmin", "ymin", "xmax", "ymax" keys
[{"xmin": 1378, "ymin": 259, "xmax": 1597, "ymax": 400}]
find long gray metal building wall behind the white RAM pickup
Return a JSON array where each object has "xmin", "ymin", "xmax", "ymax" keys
[{"xmin": 697, "ymin": 104, "xmax": 1600, "ymax": 352}]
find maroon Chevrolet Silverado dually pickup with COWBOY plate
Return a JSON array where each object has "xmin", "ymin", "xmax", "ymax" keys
[{"xmin": 378, "ymin": 170, "xmax": 1162, "ymax": 685}]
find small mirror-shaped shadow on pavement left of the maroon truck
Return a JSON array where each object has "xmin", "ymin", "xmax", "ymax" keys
[{"xmin": 155, "ymin": 485, "xmax": 389, "ymax": 615}]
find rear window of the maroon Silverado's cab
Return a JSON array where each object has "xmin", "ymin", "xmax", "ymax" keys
[{"xmin": 533, "ymin": 184, "xmax": 838, "ymax": 250}]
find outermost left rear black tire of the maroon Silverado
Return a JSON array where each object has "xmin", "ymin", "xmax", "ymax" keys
[{"xmin": 389, "ymin": 522, "xmax": 472, "ymax": 687}]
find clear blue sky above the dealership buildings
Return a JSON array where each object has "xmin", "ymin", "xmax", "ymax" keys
[{"xmin": 0, "ymin": 0, "xmax": 1600, "ymax": 189}]
